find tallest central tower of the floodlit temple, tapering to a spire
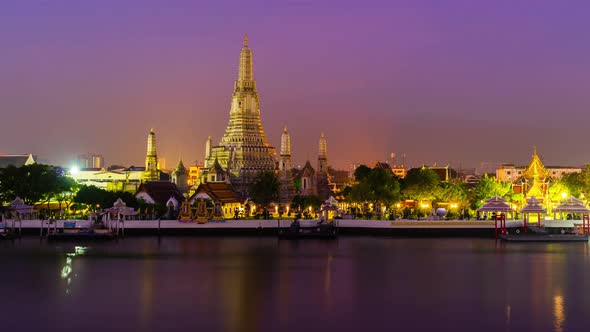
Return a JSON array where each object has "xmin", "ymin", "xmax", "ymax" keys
[{"xmin": 203, "ymin": 36, "xmax": 277, "ymax": 198}]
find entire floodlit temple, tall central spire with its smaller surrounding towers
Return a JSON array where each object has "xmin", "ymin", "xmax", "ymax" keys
[{"xmin": 141, "ymin": 37, "xmax": 333, "ymax": 205}]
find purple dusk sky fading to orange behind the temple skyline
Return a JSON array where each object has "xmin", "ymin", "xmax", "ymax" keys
[{"xmin": 0, "ymin": 0, "xmax": 590, "ymax": 169}]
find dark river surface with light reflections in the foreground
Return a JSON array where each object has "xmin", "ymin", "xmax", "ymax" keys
[{"xmin": 0, "ymin": 237, "xmax": 590, "ymax": 332}]
